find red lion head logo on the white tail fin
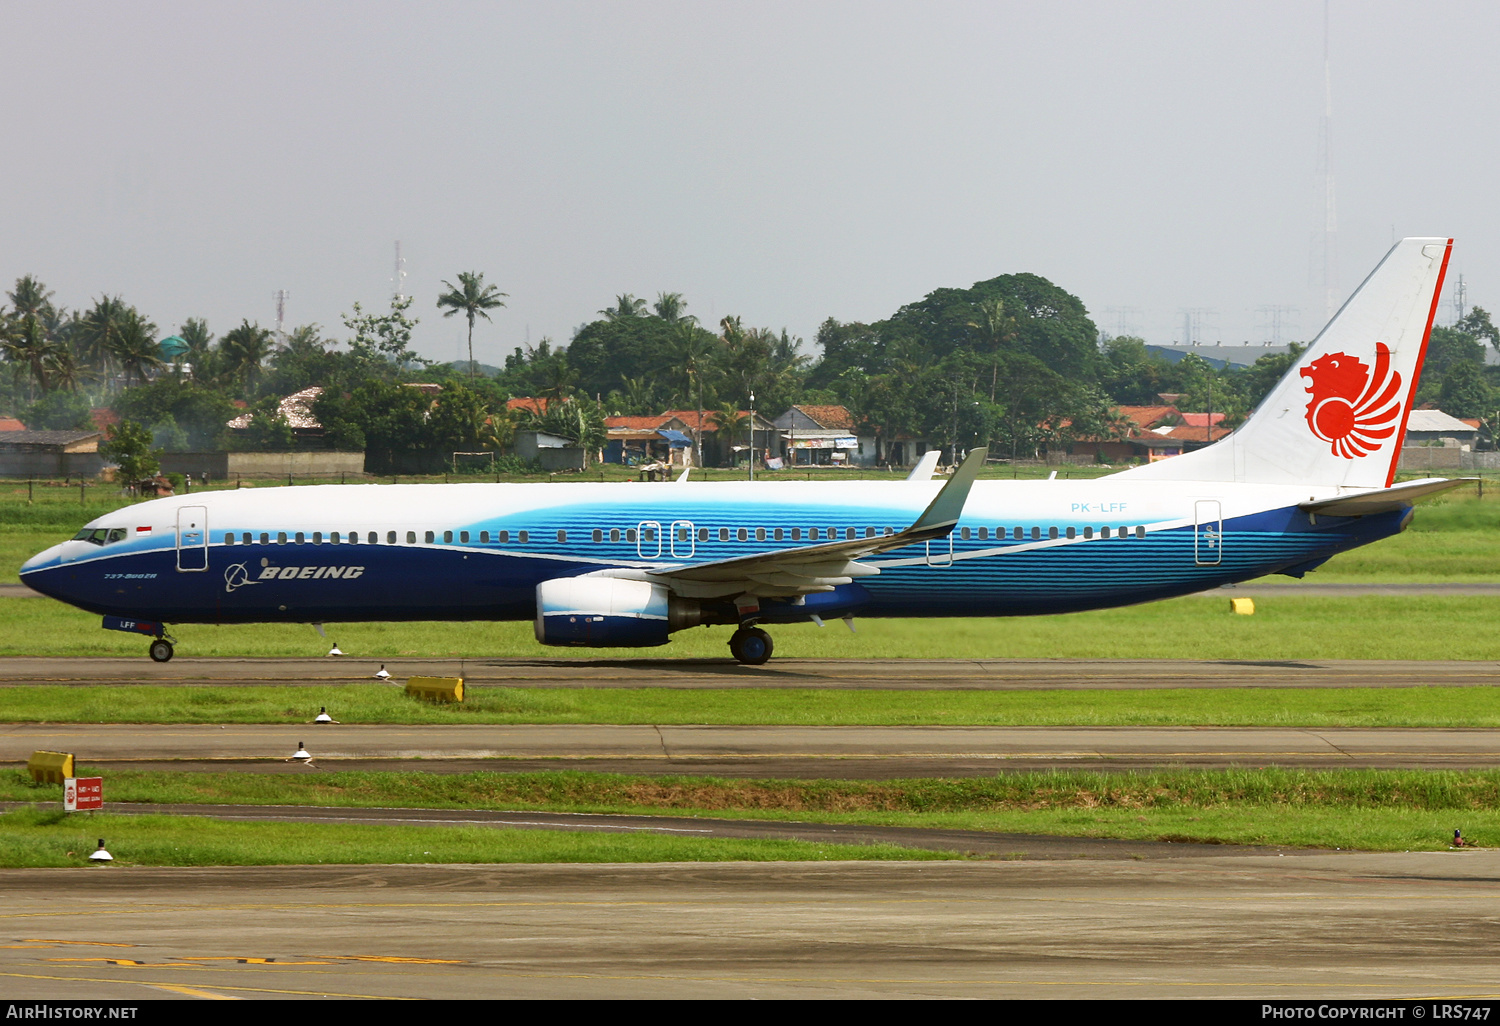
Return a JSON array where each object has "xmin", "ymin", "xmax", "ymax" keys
[{"xmin": 1302, "ymin": 342, "xmax": 1401, "ymax": 459}]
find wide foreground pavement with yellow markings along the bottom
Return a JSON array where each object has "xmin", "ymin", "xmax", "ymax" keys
[{"xmin": 0, "ymin": 851, "xmax": 1500, "ymax": 1002}]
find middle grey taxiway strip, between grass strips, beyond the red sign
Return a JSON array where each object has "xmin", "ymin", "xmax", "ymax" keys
[{"xmin": 0, "ymin": 723, "xmax": 1500, "ymax": 779}]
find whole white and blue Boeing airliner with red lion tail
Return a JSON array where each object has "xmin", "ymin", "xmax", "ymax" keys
[{"xmin": 21, "ymin": 239, "xmax": 1461, "ymax": 663}]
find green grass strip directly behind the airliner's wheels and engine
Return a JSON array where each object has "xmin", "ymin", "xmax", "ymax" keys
[{"xmin": 0, "ymin": 593, "xmax": 1500, "ymax": 660}]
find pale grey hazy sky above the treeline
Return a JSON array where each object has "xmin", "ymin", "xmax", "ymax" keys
[{"xmin": 0, "ymin": 0, "xmax": 1500, "ymax": 363}]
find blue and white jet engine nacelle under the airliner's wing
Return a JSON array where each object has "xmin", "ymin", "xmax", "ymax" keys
[{"xmin": 537, "ymin": 578, "xmax": 702, "ymax": 648}]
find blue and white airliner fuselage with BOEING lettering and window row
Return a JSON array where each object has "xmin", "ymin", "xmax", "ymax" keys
[{"xmin": 21, "ymin": 477, "xmax": 1409, "ymax": 624}]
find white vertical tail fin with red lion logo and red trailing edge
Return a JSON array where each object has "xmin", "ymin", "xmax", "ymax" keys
[{"xmin": 1124, "ymin": 239, "xmax": 1454, "ymax": 488}]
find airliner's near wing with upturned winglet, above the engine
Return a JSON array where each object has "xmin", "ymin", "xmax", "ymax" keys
[{"xmin": 645, "ymin": 449, "xmax": 987, "ymax": 597}]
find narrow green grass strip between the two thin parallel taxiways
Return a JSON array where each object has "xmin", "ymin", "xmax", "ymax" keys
[{"xmin": 0, "ymin": 684, "xmax": 1500, "ymax": 731}]
